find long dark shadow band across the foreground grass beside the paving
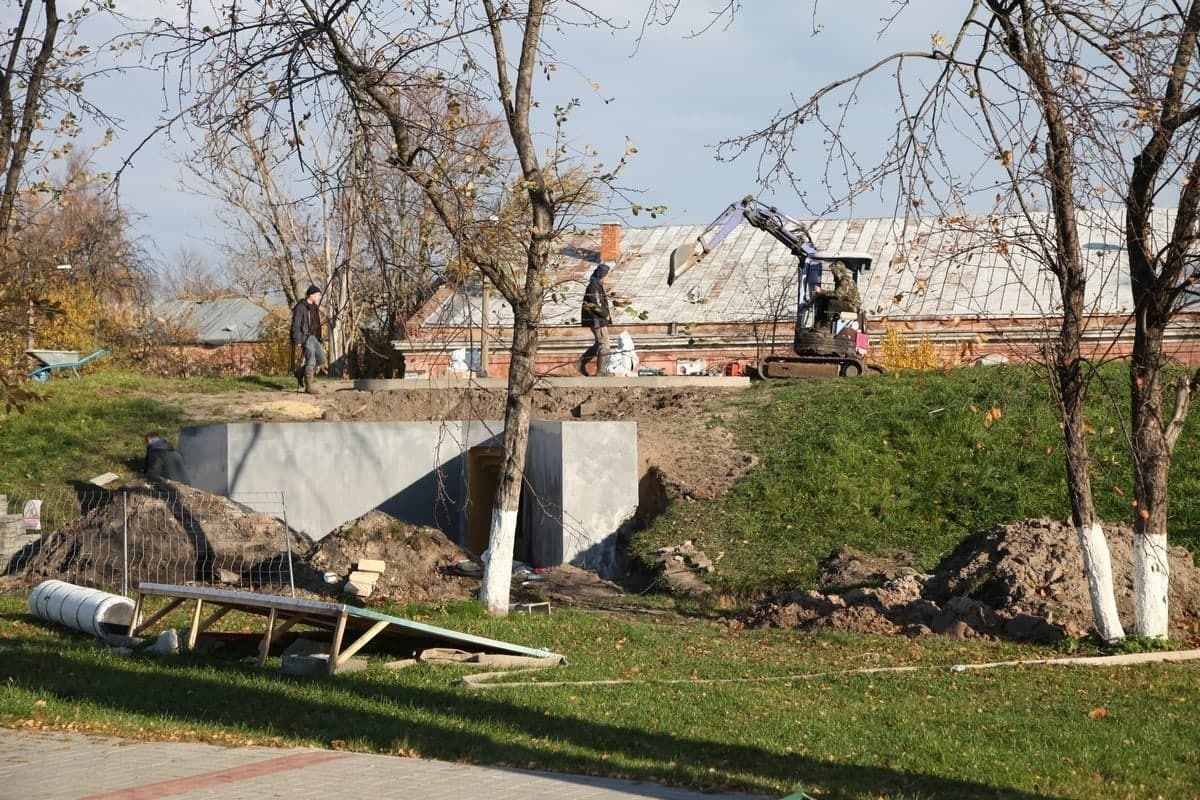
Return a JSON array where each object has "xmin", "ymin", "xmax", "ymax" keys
[{"xmin": 0, "ymin": 628, "xmax": 1048, "ymax": 800}]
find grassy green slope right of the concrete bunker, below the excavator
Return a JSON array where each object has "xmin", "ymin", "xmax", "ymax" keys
[{"xmin": 635, "ymin": 367, "xmax": 1200, "ymax": 595}]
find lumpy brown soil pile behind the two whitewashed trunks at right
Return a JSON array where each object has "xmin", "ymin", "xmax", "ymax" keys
[{"xmin": 733, "ymin": 519, "xmax": 1200, "ymax": 643}]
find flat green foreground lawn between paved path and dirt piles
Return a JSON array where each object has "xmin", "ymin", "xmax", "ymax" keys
[{"xmin": 0, "ymin": 599, "xmax": 1200, "ymax": 798}]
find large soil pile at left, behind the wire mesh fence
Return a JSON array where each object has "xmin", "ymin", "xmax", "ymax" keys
[{"xmin": 14, "ymin": 480, "xmax": 304, "ymax": 587}]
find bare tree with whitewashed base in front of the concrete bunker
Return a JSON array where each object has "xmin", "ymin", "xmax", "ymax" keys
[{"xmin": 178, "ymin": 0, "xmax": 611, "ymax": 614}]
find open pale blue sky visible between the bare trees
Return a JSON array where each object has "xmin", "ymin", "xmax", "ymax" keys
[{"xmin": 65, "ymin": 0, "xmax": 962, "ymax": 273}]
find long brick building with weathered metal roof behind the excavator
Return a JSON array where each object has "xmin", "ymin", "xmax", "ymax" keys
[{"xmin": 395, "ymin": 209, "xmax": 1200, "ymax": 377}]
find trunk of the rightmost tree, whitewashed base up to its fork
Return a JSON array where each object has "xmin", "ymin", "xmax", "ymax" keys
[{"xmin": 1129, "ymin": 324, "xmax": 1171, "ymax": 638}]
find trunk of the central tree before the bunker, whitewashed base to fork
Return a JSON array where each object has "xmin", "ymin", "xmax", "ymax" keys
[{"xmin": 479, "ymin": 303, "xmax": 540, "ymax": 616}]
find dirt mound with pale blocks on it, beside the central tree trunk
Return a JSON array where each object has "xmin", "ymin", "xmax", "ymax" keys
[{"xmin": 296, "ymin": 511, "xmax": 479, "ymax": 603}]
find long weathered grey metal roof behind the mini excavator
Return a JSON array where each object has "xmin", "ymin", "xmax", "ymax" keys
[{"xmin": 422, "ymin": 209, "xmax": 1190, "ymax": 327}]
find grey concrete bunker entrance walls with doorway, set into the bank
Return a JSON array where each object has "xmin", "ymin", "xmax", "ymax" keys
[{"xmin": 179, "ymin": 420, "xmax": 638, "ymax": 576}]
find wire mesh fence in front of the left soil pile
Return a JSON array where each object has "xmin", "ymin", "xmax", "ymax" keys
[{"xmin": 0, "ymin": 481, "xmax": 300, "ymax": 595}]
